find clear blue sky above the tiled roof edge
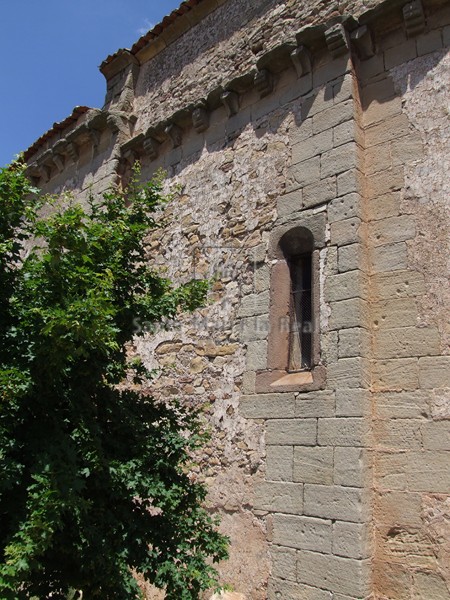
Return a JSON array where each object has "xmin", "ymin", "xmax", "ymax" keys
[{"xmin": 0, "ymin": 0, "xmax": 181, "ymax": 166}]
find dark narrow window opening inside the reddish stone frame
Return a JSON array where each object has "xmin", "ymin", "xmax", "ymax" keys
[{"xmin": 288, "ymin": 253, "xmax": 314, "ymax": 371}]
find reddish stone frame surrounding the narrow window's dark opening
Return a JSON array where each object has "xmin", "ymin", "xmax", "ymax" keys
[{"xmin": 256, "ymin": 213, "xmax": 326, "ymax": 393}]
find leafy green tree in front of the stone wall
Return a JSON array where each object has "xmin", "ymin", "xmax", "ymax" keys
[{"xmin": 0, "ymin": 163, "xmax": 227, "ymax": 600}]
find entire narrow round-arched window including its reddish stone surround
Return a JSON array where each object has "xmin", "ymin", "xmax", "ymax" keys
[{"xmin": 256, "ymin": 214, "xmax": 325, "ymax": 393}]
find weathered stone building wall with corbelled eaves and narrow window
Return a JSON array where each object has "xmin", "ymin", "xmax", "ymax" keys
[{"xmin": 26, "ymin": 0, "xmax": 450, "ymax": 600}]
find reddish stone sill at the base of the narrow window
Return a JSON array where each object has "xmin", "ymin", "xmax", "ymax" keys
[{"xmin": 256, "ymin": 366, "xmax": 326, "ymax": 394}]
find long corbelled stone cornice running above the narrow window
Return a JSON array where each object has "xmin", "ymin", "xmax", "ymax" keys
[{"xmin": 114, "ymin": 0, "xmax": 425, "ymax": 169}]
